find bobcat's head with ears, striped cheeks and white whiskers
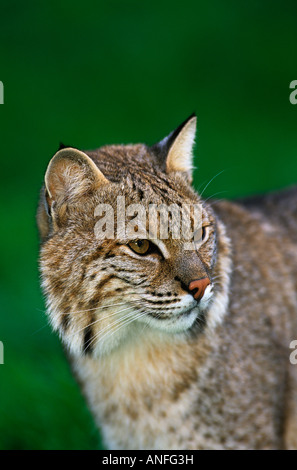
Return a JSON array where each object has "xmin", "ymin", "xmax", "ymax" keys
[{"xmin": 38, "ymin": 116, "xmax": 228, "ymax": 356}]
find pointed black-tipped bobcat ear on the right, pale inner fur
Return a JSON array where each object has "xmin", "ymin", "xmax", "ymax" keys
[{"xmin": 153, "ymin": 114, "xmax": 197, "ymax": 180}]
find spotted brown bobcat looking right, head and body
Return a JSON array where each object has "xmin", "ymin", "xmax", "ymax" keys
[{"xmin": 38, "ymin": 115, "xmax": 297, "ymax": 450}]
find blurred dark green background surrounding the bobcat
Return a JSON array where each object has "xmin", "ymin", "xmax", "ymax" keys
[{"xmin": 0, "ymin": 0, "xmax": 297, "ymax": 449}]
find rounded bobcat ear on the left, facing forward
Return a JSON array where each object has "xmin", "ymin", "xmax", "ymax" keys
[{"xmin": 45, "ymin": 147, "xmax": 109, "ymax": 202}]
